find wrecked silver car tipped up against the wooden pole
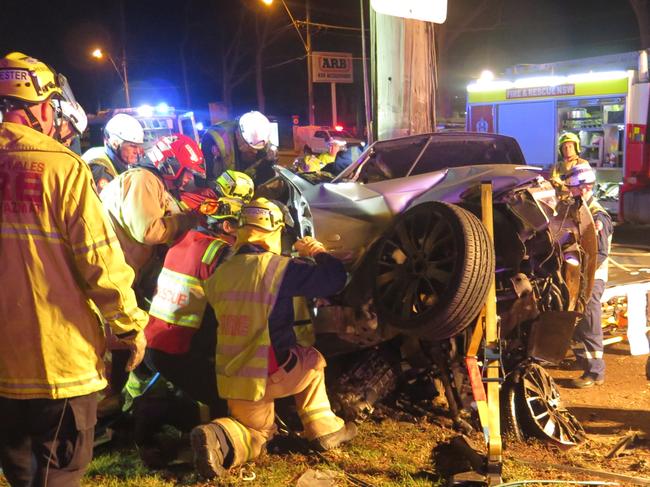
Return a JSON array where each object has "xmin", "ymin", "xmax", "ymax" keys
[{"xmin": 257, "ymin": 133, "xmax": 596, "ymax": 445}]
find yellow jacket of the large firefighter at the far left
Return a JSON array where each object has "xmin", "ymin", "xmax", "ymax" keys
[{"xmin": 0, "ymin": 123, "xmax": 147, "ymax": 399}]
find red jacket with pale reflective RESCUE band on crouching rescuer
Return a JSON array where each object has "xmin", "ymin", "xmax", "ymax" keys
[{"xmin": 145, "ymin": 230, "xmax": 229, "ymax": 354}]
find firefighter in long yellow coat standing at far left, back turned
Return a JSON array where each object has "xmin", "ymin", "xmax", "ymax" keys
[{"xmin": 0, "ymin": 52, "xmax": 147, "ymax": 487}]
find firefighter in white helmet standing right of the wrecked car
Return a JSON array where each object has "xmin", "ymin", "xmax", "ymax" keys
[{"xmin": 565, "ymin": 162, "xmax": 613, "ymax": 389}]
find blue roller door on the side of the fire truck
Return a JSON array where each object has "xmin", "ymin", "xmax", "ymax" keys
[{"xmin": 497, "ymin": 101, "xmax": 556, "ymax": 166}]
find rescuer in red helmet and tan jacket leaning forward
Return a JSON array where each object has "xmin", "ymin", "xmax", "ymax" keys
[{"xmin": 100, "ymin": 135, "xmax": 205, "ymax": 416}]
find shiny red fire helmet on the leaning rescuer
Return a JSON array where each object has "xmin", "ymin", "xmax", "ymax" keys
[{"xmin": 146, "ymin": 134, "xmax": 205, "ymax": 181}]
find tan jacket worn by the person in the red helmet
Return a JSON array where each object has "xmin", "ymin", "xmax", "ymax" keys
[{"xmin": 100, "ymin": 167, "xmax": 196, "ymax": 274}]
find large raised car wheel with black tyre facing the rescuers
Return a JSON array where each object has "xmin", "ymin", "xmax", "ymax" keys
[{"xmin": 374, "ymin": 202, "xmax": 494, "ymax": 340}]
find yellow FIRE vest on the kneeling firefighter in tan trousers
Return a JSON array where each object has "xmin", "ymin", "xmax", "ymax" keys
[{"xmin": 205, "ymin": 252, "xmax": 291, "ymax": 401}]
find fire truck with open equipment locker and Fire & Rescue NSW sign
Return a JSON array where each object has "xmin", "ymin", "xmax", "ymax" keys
[{"xmin": 466, "ymin": 50, "xmax": 650, "ymax": 223}]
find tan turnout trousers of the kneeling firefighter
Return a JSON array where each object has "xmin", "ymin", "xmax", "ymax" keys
[{"xmin": 213, "ymin": 347, "xmax": 345, "ymax": 467}]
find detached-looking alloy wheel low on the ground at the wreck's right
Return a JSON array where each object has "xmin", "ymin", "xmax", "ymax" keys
[{"xmin": 514, "ymin": 363, "xmax": 587, "ymax": 448}]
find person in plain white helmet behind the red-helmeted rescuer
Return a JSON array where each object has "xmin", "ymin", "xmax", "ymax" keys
[{"xmin": 81, "ymin": 113, "xmax": 144, "ymax": 192}]
